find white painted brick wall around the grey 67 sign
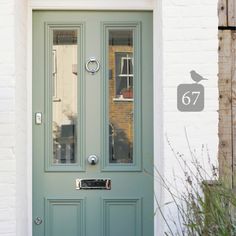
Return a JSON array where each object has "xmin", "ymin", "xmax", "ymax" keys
[{"xmin": 162, "ymin": 0, "xmax": 218, "ymax": 233}]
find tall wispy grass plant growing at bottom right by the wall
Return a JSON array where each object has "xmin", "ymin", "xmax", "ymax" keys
[{"xmin": 155, "ymin": 131, "xmax": 236, "ymax": 236}]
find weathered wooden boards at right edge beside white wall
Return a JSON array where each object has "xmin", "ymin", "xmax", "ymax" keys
[{"xmin": 218, "ymin": 0, "xmax": 236, "ymax": 227}]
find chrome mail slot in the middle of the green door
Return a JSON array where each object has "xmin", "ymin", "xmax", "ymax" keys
[{"xmin": 76, "ymin": 179, "xmax": 111, "ymax": 190}]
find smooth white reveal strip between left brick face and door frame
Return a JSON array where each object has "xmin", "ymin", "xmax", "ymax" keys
[{"xmin": 14, "ymin": 0, "xmax": 28, "ymax": 236}]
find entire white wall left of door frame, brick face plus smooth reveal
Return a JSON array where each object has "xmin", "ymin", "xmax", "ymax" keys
[{"xmin": 0, "ymin": 0, "xmax": 27, "ymax": 236}]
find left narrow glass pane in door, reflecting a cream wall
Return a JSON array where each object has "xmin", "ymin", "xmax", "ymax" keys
[{"xmin": 52, "ymin": 30, "xmax": 78, "ymax": 164}]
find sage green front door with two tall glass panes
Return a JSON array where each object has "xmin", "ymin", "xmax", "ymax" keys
[{"xmin": 33, "ymin": 11, "xmax": 154, "ymax": 236}]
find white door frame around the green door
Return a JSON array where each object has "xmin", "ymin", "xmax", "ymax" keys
[{"xmin": 27, "ymin": 0, "xmax": 164, "ymax": 236}]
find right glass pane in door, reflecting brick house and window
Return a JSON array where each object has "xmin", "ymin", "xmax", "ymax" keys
[{"xmin": 109, "ymin": 30, "xmax": 134, "ymax": 163}]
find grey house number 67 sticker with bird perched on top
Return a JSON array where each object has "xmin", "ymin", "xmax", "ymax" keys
[{"xmin": 177, "ymin": 71, "xmax": 207, "ymax": 112}]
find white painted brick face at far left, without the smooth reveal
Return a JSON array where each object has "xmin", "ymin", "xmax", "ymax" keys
[{"xmin": 0, "ymin": 0, "xmax": 16, "ymax": 236}]
